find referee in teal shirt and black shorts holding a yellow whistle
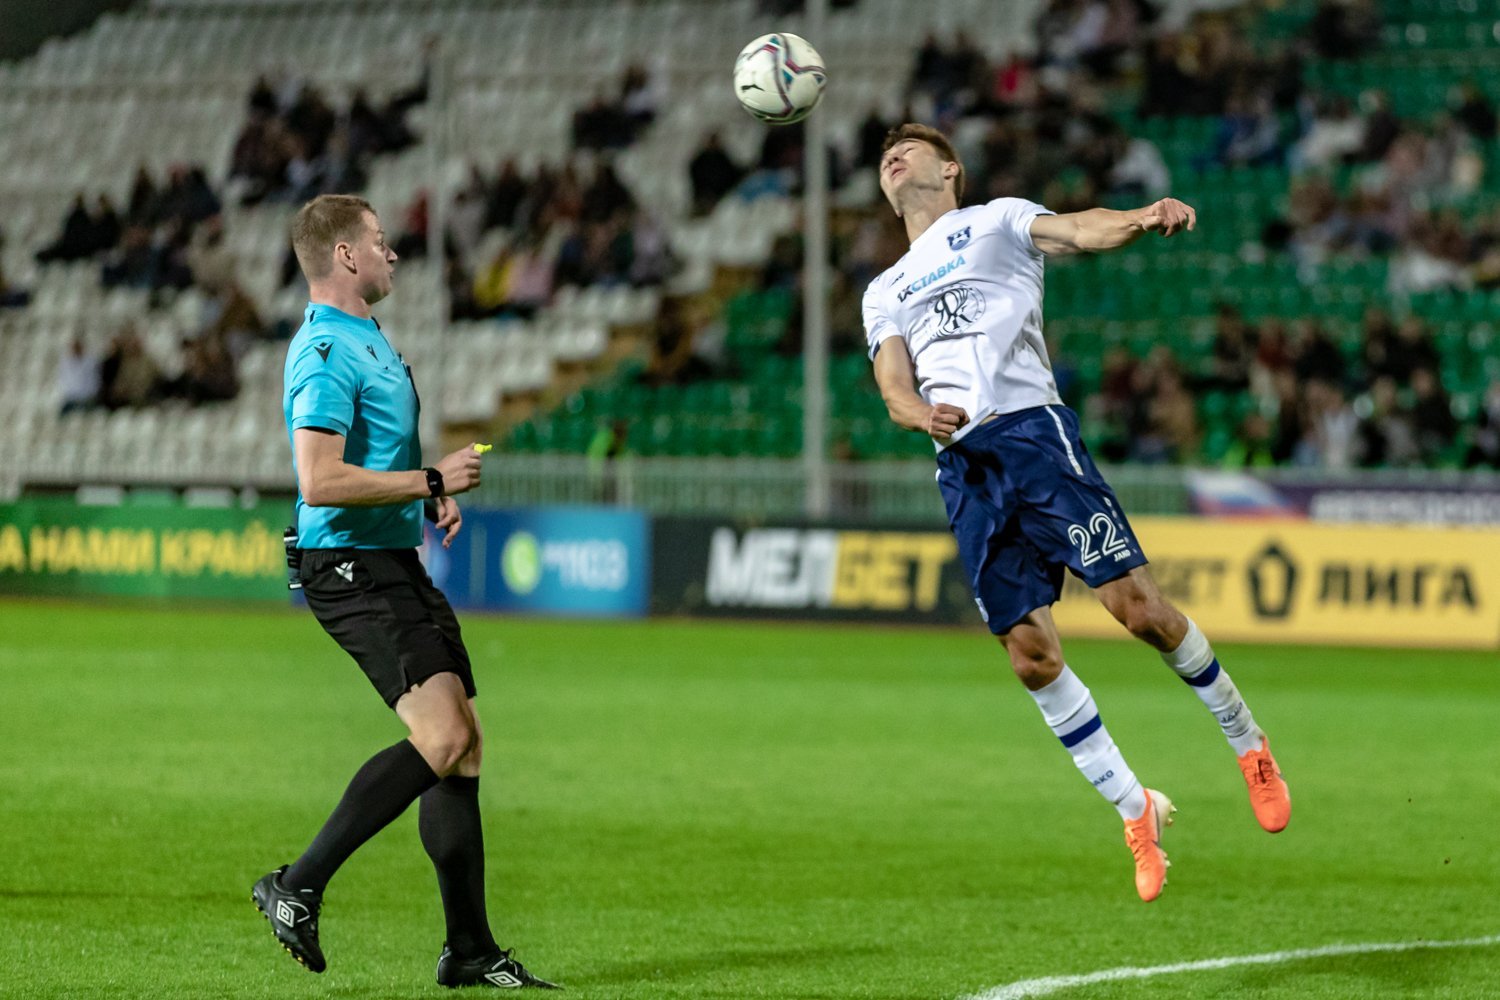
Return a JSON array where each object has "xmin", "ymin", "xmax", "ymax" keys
[{"xmin": 252, "ymin": 195, "xmax": 555, "ymax": 988}]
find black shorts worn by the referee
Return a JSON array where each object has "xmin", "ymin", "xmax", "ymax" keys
[{"xmin": 300, "ymin": 549, "xmax": 474, "ymax": 708}]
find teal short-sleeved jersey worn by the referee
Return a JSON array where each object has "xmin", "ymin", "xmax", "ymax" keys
[{"xmin": 282, "ymin": 303, "xmax": 422, "ymax": 549}]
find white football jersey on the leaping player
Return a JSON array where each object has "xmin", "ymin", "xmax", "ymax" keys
[{"xmin": 864, "ymin": 198, "xmax": 1062, "ymax": 450}]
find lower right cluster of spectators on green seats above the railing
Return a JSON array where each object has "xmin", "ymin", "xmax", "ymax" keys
[{"xmin": 1085, "ymin": 306, "xmax": 1500, "ymax": 468}]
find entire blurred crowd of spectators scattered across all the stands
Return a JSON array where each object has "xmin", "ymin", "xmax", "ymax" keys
[{"xmin": 14, "ymin": 0, "xmax": 1500, "ymax": 468}]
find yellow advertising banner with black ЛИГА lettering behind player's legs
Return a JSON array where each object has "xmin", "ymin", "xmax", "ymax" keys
[{"xmin": 1053, "ymin": 517, "xmax": 1500, "ymax": 649}]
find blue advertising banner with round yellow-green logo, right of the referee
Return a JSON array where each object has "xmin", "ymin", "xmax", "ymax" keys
[{"xmin": 423, "ymin": 507, "xmax": 651, "ymax": 618}]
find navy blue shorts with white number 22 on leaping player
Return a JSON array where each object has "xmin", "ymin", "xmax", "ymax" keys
[{"xmin": 938, "ymin": 406, "xmax": 1146, "ymax": 636}]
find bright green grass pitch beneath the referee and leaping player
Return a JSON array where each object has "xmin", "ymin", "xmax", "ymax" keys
[{"xmin": 0, "ymin": 601, "xmax": 1500, "ymax": 1000}]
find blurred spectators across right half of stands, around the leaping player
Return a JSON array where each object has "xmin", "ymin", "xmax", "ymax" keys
[{"xmin": 654, "ymin": 0, "xmax": 1500, "ymax": 468}]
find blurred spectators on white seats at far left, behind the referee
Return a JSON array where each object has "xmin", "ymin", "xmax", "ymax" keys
[{"xmin": 35, "ymin": 59, "xmax": 441, "ymax": 412}]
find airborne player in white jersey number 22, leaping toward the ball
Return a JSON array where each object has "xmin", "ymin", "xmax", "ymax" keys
[{"xmin": 864, "ymin": 124, "xmax": 1292, "ymax": 903}]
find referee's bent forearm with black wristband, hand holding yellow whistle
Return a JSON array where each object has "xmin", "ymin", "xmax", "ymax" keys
[{"xmin": 293, "ymin": 427, "xmax": 480, "ymax": 507}]
